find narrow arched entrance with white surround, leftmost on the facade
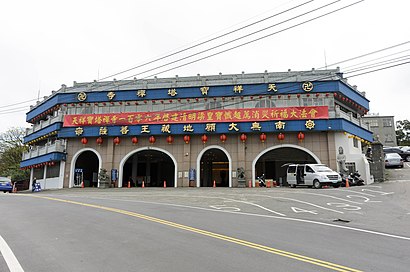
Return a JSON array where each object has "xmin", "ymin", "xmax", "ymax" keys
[{"xmin": 71, "ymin": 149, "xmax": 100, "ymax": 187}]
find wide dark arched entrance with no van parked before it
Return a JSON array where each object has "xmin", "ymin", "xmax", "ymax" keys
[{"xmin": 119, "ymin": 148, "xmax": 176, "ymax": 187}]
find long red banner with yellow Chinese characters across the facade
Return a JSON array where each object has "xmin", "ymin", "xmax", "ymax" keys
[{"xmin": 63, "ymin": 106, "xmax": 329, "ymax": 127}]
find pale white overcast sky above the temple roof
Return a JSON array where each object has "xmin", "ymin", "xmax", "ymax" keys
[{"xmin": 0, "ymin": 0, "xmax": 410, "ymax": 132}]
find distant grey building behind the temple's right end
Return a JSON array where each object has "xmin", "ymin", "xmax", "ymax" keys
[{"xmin": 363, "ymin": 115, "xmax": 397, "ymax": 146}]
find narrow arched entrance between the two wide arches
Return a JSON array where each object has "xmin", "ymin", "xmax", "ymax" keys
[{"xmin": 197, "ymin": 146, "xmax": 232, "ymax": 187}]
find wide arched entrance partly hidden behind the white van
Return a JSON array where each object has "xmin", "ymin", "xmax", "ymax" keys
[{"xmin": 252, "ymin": 144, "xmax": 320, "ymax": 187}]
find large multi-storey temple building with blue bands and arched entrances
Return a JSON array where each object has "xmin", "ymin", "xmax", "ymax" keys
[{"xmin": 20, "ymin": 69, "xmax": 372, "ymax": 189}]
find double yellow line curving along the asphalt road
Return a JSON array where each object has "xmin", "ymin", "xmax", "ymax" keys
[{"xmin": 30, "ymin": 195, "xmax": 361, "ymax": 272}]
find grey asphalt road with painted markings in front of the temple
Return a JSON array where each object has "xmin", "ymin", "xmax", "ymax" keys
[{"xmin": 0, "ymin": 165, "xmax": 410, "ymax": 272}]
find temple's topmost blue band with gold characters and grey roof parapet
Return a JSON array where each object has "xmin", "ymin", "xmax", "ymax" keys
[{"xmin": 26, "ymin": 70, "xmax": 369, "ymax": 123}]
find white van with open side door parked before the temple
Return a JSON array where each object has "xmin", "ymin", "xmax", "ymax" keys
[{"xmin": 286, "ymin": 164, "xmax": 342, "ymax": 189}]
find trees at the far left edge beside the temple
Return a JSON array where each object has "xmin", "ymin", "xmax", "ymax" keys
[{"xmin": 0, "ymin": 128, "xmax": 29, "ymax": 181}]
